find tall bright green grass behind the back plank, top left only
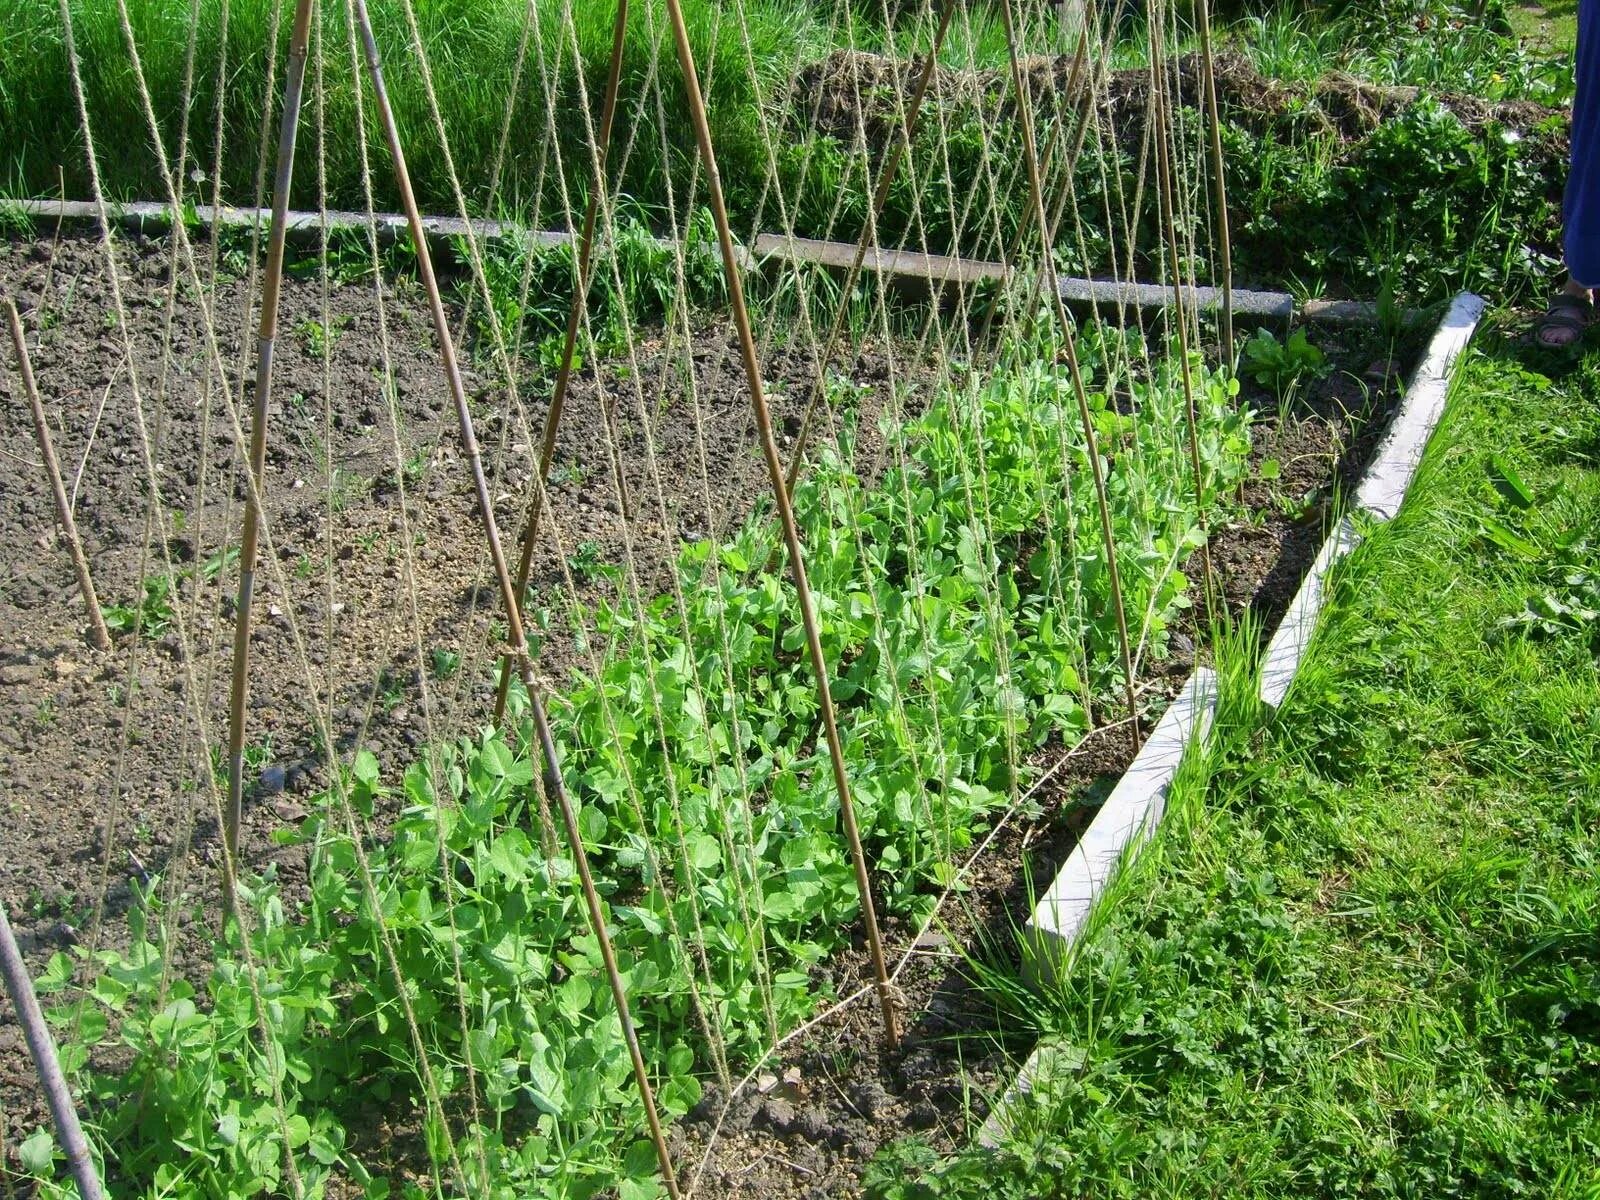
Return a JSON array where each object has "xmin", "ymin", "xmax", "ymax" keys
[{"xmin": 0, "ymin": 0, "xmax": 826, "ymax": 221}]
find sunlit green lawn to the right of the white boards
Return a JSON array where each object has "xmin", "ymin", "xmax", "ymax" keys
[{"xmin": 874, "ymin": 324, "xmax": 1600, "ymax": 1200}]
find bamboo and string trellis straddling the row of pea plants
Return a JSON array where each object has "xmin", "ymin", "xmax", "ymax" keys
[{"xmin": 0, "ymin": 0, "xmax": 1240, "ymax": 1197}]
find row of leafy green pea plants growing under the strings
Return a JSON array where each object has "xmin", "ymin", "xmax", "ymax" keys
[{"xmin": 30, "ymin": 330, "xmax": 1250, "ymax": 1200}]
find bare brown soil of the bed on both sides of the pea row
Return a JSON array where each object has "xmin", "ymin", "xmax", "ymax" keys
[{"xmin": 0, "ymin": 224, "xmax": 1395, "ymax": 1195}]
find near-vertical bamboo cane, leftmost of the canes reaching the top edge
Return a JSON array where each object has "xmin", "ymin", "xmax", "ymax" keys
[{"xmin": 222, "ymin": 0, "xmax": 312, "ymax": 888}]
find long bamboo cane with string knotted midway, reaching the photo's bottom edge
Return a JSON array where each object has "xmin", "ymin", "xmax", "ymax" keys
[{"xmin": 352, "ymin": 0, "xmax": 678, "ymax": 1200}]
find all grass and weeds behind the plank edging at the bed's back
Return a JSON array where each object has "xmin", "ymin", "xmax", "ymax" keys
[{"xmin": 0, "ymin": 0, "xmax": 1570, "ymax": 302}]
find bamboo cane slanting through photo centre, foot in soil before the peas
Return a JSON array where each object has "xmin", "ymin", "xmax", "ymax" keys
[{"xmin": 667, "ymin": 0, "xmax": 899, "ymax": 1050}]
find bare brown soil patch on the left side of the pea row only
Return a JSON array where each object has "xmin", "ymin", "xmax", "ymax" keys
[{"xmin": 0, "ymin": 224, "xmax": 918, "ymax": 1147}]
